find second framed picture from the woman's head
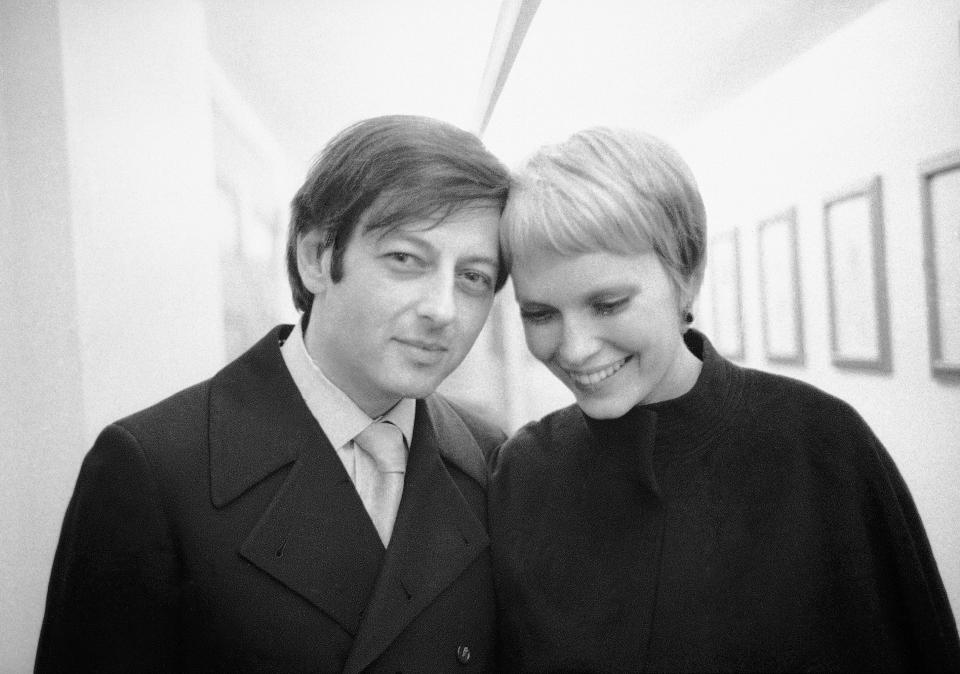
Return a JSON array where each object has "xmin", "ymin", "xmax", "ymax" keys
[{"xmin": 757, "ymin": 208, "xmax": 804, "ymax": 365}]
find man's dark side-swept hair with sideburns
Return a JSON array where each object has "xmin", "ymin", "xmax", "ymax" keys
[{"xmin": 287, "ymin": 115, "xmax": 510, "ymax": 313}]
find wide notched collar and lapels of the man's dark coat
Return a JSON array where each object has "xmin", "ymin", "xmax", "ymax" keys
[{"xmin": 210, "ymin": 326, "xmax": 489, "ymax": 660}]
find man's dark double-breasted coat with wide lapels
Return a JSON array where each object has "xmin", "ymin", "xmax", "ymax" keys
[{"xmin": 36, "ymin": 327, "xmax": 503, "ymax": 672}]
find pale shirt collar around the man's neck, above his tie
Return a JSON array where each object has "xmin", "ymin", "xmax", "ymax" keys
[{"xmin": 280, "ymin": 324, "xmax": 416, "ymax": 449}]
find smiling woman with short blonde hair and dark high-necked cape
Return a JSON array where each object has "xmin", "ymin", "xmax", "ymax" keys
[{"xmin": 490, "ymin": 129, "xmax": 960, "ymax": 671}]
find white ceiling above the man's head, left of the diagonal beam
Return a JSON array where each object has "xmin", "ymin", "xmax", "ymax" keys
[{"xmin": 203, "ymin": 0, "xmax": 500, "ymax": 174}]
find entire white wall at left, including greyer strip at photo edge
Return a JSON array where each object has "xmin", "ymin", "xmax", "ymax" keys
[{"xmin": 0, "ymin": 0, "xmax": 230, "ymax": 672}]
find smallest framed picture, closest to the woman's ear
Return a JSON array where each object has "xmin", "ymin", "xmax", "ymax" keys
[{"xmin": 708, "ymin": 229, "xmax": 745, "ymax": 360}]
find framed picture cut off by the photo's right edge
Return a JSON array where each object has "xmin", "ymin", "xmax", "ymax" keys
[{"xmin": 920, "ymin": 150, "xmax": 960, "ymax": 379}]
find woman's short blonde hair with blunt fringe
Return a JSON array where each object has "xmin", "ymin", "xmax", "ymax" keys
[{"xmin": 500, "ymin": 127, "xmax": 706, "ymax": 312}]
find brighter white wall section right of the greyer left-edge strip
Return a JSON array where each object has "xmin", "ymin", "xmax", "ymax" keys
[{"xmin": 60, "ymin": 0, "xmax": 223, "ymax": 440}]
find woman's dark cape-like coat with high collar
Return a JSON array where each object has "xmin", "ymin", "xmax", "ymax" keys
[{"xmin": 489, "ymin": 332, "xmax": 960, "ymax": 672}]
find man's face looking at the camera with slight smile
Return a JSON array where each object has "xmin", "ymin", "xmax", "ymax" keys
[{"xmin": 301, "ymin": 204, "xmax": 500, "ymax": 417}]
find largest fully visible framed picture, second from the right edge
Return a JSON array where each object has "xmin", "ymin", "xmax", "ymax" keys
[{"xmin": 823, "ymin": 176, "xmax": 892, "ymax": 372}]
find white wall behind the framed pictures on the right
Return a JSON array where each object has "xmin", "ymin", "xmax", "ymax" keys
[{"xmin": 678, "ymin": 0, "xmax": 960, "ymax": 615}]
